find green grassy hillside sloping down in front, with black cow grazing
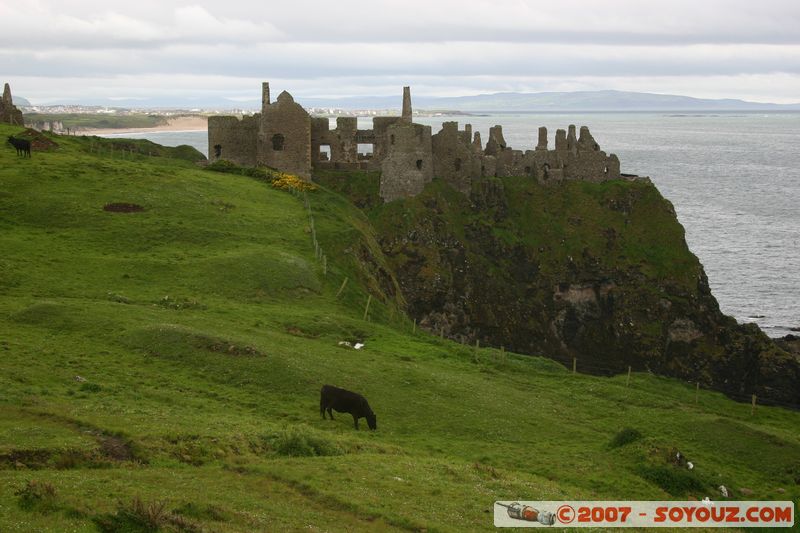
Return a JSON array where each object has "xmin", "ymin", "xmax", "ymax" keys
[{"xmin": 0, "ymin": 122, "xmax": 800, "ymax": 532}]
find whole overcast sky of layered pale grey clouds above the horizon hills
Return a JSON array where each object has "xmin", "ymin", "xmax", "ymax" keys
[{"xmin": 0, "ymin": 0, "xmax": 800, "ymax": 104}]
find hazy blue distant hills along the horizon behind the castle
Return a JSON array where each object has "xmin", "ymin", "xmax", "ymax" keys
[{"xmin": 14, "ymin": 88, "xmax": 800, "ymax": 112}]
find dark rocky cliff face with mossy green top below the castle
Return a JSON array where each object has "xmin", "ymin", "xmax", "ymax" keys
[{"xmin": 316, "ymin": 172, "xmax": 800, "ymax": 404}]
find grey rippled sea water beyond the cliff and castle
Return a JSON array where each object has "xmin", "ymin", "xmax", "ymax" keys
[{"xmin": 101, "ymin": 112, "xmax": 800, "ymax": 337}]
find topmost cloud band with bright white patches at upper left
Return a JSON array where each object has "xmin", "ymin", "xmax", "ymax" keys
[{"xmin": 0, "ymin": 0, "xmax": 800, "ymax": 49}]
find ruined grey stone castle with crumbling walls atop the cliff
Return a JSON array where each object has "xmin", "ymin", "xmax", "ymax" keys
[{"xmin": 208, "ymin": 82, "xmax": 620, "ymax": 202}]
